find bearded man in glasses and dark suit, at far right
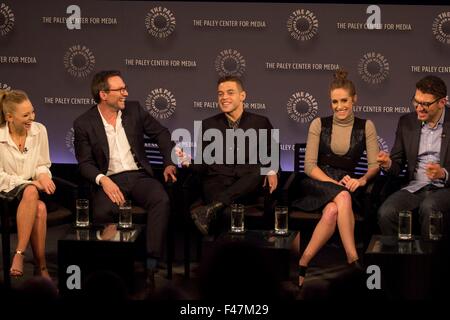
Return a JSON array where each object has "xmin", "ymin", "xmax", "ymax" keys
[{"xmin": 377, "ymin": 75, "xmax": 450, "ymax": 238}]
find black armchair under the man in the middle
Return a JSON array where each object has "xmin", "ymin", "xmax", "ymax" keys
[{"xmin": 181, "ymin": 169, "xmax": 275, "ymax": 278}]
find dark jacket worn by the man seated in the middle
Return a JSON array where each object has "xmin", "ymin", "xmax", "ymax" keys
[{"xmin": 194, "ymin": 111, "xmax": 273, "ymax": 177}]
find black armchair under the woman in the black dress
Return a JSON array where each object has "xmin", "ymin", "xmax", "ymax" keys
[{"xmin": 281, "ymin": 143, "xmax": 385, "ymax": 250}]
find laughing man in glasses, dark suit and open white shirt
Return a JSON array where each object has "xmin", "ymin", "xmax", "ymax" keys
[{"xmin": 74, "ymin": 71, "xmax": 176, "ymax": 270}]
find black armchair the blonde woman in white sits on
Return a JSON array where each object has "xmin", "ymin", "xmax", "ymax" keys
[{"xmin": 0, "ymin": 176, "xmax": 77, "ymax": 288}]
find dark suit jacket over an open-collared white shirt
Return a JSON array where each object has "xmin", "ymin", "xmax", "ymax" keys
[{"xmin": 74, "ymin": 101, "xmax": 173, "ymax": 183}]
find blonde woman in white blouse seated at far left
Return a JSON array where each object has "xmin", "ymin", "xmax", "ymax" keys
[{"xmin": 0, "ymin": 90, "xmax": 55, "ymax": 278}]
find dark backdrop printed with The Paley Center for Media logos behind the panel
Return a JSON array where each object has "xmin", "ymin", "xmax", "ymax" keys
[{"xmin": 0, "ymin": 0, "xmax": 450, "ymax": 170}]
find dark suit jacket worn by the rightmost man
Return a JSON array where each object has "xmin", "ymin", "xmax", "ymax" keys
[{"xmin": 389, "ymin": 107, "xmax": 450, "ymax": 187}]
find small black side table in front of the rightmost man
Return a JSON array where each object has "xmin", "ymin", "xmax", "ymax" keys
[{"xmin": 365, "ymin": 235, "xmax": 450, "ymax": 299}]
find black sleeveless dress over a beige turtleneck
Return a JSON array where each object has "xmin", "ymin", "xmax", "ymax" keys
[{"xmin": 292, "ymin": 117, "xmax": 366, "ymax": 211}]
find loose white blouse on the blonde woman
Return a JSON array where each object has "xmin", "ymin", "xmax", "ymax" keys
[{"xmin": 0, "ymin": 122, "xmax": 52, "ymax": 192}]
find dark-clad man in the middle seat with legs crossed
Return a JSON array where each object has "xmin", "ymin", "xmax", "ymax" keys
[{"xmin": 181, "ymin": 76, "xmax": 278, "ymax": 235}]
